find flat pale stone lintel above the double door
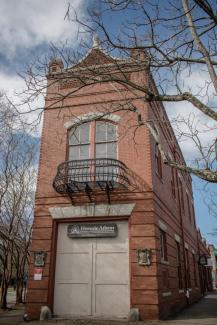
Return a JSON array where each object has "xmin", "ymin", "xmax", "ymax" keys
[{"xmin": 49, "ymin": 203, "xmax": 135, "ymax": 219}]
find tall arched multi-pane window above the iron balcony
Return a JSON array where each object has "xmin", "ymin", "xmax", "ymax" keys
[{"xmin": 68, "ymin": 120, "xmax": 117, "ymax": 160}]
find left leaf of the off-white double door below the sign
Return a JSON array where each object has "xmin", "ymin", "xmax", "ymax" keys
[{"xmin": 54, "ymin": 224, "xmax": 92, "ymax": 316}]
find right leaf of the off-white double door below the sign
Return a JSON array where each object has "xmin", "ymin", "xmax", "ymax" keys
[{"xmin": 92, "ymin": 221, "xmax": 130, "ymax": 317}]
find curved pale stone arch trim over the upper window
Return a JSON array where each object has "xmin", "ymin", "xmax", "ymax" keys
[{"xmin": 64, "ymin": 112, "xmax": 121, "ymax": 129}]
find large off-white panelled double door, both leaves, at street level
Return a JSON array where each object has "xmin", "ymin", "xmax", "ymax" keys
[{"xmin": 54, "ymin": 221, "xmax": 130, "ymax": 318}]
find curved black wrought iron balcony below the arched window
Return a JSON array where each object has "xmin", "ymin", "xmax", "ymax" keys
[{"xmin": 53, "ymin": 158, "xmax": 130, "ymax": 202}]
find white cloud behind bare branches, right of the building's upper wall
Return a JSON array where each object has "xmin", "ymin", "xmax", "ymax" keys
[{"xmin": 165, "ymin": 68, "xmax": 217, "ymax": 165}]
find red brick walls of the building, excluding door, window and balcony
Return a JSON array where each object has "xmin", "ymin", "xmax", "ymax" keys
[{"xmin": 26, "ymin": 45, "xmax": 212, "ymax": 319}]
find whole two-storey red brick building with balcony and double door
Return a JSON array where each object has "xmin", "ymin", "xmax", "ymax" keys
[{"xmin": 26, "ymin": 38, "xmax": 211, "ymax": 319}]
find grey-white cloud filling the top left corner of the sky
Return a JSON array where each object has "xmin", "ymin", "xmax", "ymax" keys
[{"xmin": 0, "ymin": 0, "xmax": 84, "ymax": 57}]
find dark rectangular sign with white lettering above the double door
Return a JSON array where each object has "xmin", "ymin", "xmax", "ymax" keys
[{"xmin": 67, "ymin": 223, "xmax": 118, "ymax": 238}]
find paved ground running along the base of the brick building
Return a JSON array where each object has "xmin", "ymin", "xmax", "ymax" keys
[{"xmin": 0, "ymin": 292, "xmax": 217, "ymax": 325}]
